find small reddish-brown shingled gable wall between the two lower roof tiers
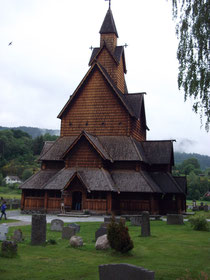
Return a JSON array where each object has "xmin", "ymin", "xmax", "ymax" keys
[{"xmin": 66, "ymin": 138, "xmax": 103, "ymax": 168}]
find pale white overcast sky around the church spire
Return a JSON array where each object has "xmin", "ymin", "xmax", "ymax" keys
[{"xmin": 0, "ymin": 0, "xmax": 210, "ymax": 156}]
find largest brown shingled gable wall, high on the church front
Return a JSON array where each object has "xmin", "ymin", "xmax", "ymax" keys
[{"xmin": 61, "ymin": 70, "xmax": 130, "ymax": 136}]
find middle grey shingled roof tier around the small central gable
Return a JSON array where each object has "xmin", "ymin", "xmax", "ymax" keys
[{"xmin": 40, "ymin": 131, "xmax": 173, "ymax": 165}]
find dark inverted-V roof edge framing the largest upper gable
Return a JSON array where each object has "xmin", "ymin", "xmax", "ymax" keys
[{"xmin": 58, "ymin": 62, "xmax": 142, "ymax": 118}]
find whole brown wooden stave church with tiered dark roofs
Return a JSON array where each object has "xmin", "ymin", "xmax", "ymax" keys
[{"xmin": 21, "ymin": 5, "xmax": 186, "ymax": 214}]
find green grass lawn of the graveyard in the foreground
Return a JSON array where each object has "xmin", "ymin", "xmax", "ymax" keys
[{"xmin": 0, "ymin": 221, "xmax": 210, "ymax": 280}]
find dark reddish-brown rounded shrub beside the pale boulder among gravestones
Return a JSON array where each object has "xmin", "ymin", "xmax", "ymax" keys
[{"xmin": 107, "ymin": 217, "xmax": 133, "ymax": 253}]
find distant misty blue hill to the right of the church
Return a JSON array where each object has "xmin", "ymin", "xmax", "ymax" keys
[{"xmin": 174, "ymin": 152, "xmax": 210, "ymax": 170}]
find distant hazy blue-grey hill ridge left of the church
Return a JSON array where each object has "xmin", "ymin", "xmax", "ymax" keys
[{"xmin": 0, "ymin": 126, "xmax": 60, "ymax": 138}]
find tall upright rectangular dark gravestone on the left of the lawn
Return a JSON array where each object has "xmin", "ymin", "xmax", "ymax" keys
[{"xmin": 31, "ymin": 214, "xmax": 46, "ymax": 245}]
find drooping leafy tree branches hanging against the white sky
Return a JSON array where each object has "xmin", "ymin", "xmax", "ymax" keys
[{"xmin": 172, "ymin": 0, "xmax": 210, "ymax": 131}]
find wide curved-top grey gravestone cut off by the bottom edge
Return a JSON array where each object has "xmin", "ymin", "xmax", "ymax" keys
[{"xmin": 99, "ymin": 263, "xmax": 155, "ymax": 280}]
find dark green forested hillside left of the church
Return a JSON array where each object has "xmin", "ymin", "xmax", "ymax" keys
[{"xmin": 0, "ymin": 129, "xmax": 57, "ymax": 184}]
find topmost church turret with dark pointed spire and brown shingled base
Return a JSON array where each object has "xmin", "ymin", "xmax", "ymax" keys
[{"xmin": 99, "ymin": 8, "xmax": 118, "ymax": 51}]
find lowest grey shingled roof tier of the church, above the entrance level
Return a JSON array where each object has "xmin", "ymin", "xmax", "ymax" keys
[{"xmin": 20, "ymin": 168, "xmax": 185, "ymax": 194}]
